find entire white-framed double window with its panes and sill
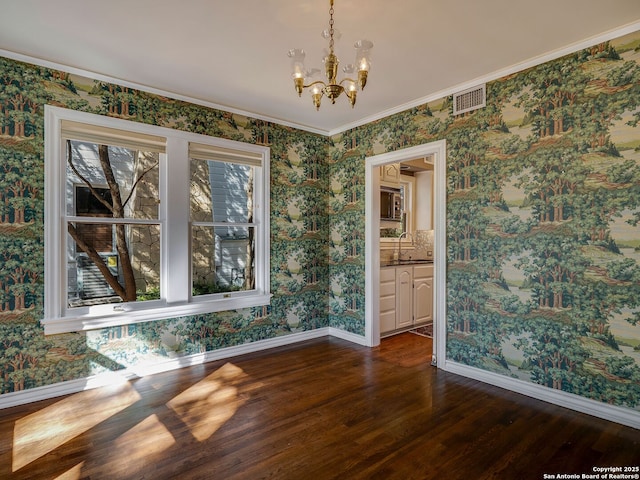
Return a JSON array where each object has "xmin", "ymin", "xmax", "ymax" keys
[{"xmin": 42, "ymin": 106, "xmax": 270, "ymax": 333}]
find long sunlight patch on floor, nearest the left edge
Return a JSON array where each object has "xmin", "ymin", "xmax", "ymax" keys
[{"xmin": 12, "ymin": 383, "xmax": 140, "ymax": 472}]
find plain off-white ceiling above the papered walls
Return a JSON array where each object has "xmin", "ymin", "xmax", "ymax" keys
[{"xmin": 0, "ymin": 0, "xmax": 640, "ymax": 134}]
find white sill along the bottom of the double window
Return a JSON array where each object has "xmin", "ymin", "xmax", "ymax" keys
[{"xmin": 40, "ymin": 294, "xmax": 271, "ymax": 335}]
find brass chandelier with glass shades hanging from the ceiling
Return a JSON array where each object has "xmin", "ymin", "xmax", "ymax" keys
[{"xmin": 289, "ymin": 0, "xmax": 373, "ymax": 110}]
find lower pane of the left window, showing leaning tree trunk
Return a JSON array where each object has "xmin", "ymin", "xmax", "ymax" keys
[{"xmin": 67, "ymin": 223, "xmax": 160, "ymax": 307}]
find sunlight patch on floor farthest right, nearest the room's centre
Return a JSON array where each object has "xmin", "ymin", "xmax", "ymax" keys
[{"xmin": 167, "ymin": 363, "xmax": 246, "ymax": 442}]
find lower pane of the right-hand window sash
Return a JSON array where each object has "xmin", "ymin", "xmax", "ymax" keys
[{"xmin": 191, "ymin": 226, "xmax": 255, "ymax": 296}]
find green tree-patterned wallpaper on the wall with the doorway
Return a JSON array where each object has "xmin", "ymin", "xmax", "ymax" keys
[{"xmin": 329, "ymin": 32, "xmax": 640, "ymax": 410}]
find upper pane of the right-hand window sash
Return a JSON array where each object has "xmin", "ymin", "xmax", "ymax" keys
[{"xmin": 191, "ymin": 159, "xmax": 254, "ymax": 223}]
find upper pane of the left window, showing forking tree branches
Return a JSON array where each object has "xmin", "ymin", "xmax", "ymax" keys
[{"xmin": 66, "ymin": 141, "xmax": 159, "ymax": 219}]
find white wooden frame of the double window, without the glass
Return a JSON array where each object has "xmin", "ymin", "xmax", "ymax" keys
[{"xmin": 41, "ymin": 105, "xmax": 271, "ymax": 334}]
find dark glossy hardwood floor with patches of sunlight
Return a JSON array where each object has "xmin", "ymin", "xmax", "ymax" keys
[{"xmin": 0, "ymin": 333, "xmax": 640, "ymax": 480}]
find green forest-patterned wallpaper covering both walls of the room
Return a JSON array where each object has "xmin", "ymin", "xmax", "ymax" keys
[{"xmin": 0, "ymin": 28, "xmax": 640, "ymax": 411}]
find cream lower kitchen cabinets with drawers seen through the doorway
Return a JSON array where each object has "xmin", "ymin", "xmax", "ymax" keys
[{"xmin": 380, "ymin": 265, "xmax": 433, "ymax": 335}]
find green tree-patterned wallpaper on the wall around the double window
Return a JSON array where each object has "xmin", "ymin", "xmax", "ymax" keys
[{"xmin": 0, "ymin": 58, "xmax": 330, "ymax": 394}]
